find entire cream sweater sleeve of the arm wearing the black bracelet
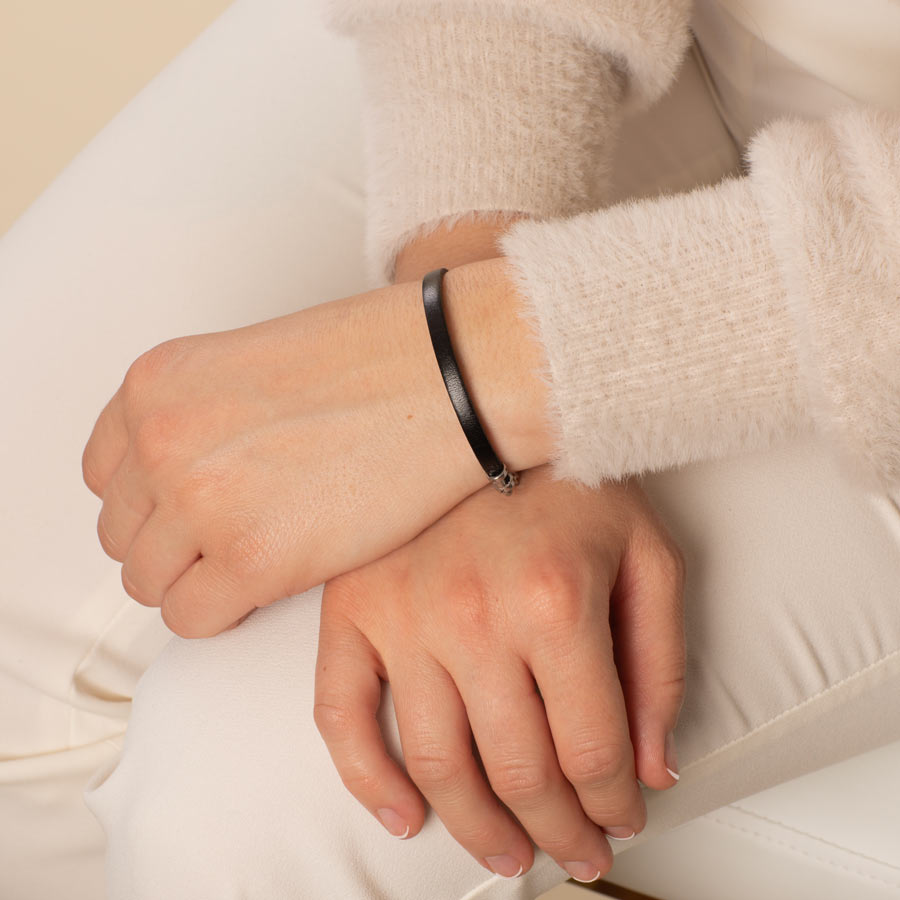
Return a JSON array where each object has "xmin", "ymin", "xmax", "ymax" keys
[{"xmin": 500, "ymin": 107, "xmax": 900, "ymax": 490}]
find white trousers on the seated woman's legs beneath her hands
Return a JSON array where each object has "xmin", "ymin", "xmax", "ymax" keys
[{"xmin": 0, "ymin": 0, "xmax": 900, "ymax": 900}]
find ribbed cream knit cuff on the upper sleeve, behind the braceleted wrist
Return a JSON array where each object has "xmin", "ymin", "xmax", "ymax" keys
[{"xmin": 359, "ymin": 13, "xmax": 622, "ymax": 284}]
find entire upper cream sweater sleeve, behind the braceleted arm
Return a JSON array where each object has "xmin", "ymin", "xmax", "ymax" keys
[{"xmin": 324, "ymin": 0, "xmax": 691, "ymax": 286}]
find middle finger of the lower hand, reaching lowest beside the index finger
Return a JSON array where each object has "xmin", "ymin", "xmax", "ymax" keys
[{"xmin": 459, "ymin": 659, "xmax": 613, "ymax": 881}]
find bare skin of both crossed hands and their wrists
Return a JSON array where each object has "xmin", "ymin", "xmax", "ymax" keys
[{"xmin": 82, "ymin": 214, "xmax": 684, "ymax": 880}]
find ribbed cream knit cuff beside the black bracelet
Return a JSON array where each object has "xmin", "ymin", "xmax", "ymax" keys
[{"xmin": 500, "ymin": 179, "xmax": 812, "ymax": 486}]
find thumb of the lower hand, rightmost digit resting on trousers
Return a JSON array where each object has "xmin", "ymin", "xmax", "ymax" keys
[{"xmin": 610, "ymin": 539, "xmax": 687, "ymax": 790}]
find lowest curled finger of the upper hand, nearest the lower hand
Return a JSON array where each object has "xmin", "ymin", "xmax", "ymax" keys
[{"xmin": 160, "ymin": 550, "xmax": 253, "ymax": 638}]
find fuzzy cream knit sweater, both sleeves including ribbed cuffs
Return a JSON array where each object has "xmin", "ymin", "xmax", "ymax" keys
[{"xmin": 326, "ymin": 0, "xmax": 900, "ymax": 490}]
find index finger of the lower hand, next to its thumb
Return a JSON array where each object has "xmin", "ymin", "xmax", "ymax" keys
[{"xmin": 527, "ymin": 588, "xmax": 647, "ymax": 838}]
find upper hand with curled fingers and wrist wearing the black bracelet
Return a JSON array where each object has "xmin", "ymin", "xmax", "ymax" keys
[{"xmin": 82, "ymin": 258, "xmax": 547, "ymax": 637}]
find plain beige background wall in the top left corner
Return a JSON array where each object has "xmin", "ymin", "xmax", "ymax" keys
[{"xmin": 0, "ymin": 0, "xmax": 231, "ymax": 234}]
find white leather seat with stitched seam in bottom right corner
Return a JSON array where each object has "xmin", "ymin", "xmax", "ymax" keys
[{"xmin": 606, "ymin": 740, "xmax": 900, "ymax": 900}]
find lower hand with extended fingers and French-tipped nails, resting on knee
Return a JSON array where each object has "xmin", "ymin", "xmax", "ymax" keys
[{"xmin": 315, "ymin": 466, "xmax": 685, "ymax": 881}]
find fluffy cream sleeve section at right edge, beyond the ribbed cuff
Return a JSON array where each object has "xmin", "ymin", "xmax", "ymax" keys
[{"xmin": 748, "ymin": 106, "xmax": 900, "ymax": 500}]
